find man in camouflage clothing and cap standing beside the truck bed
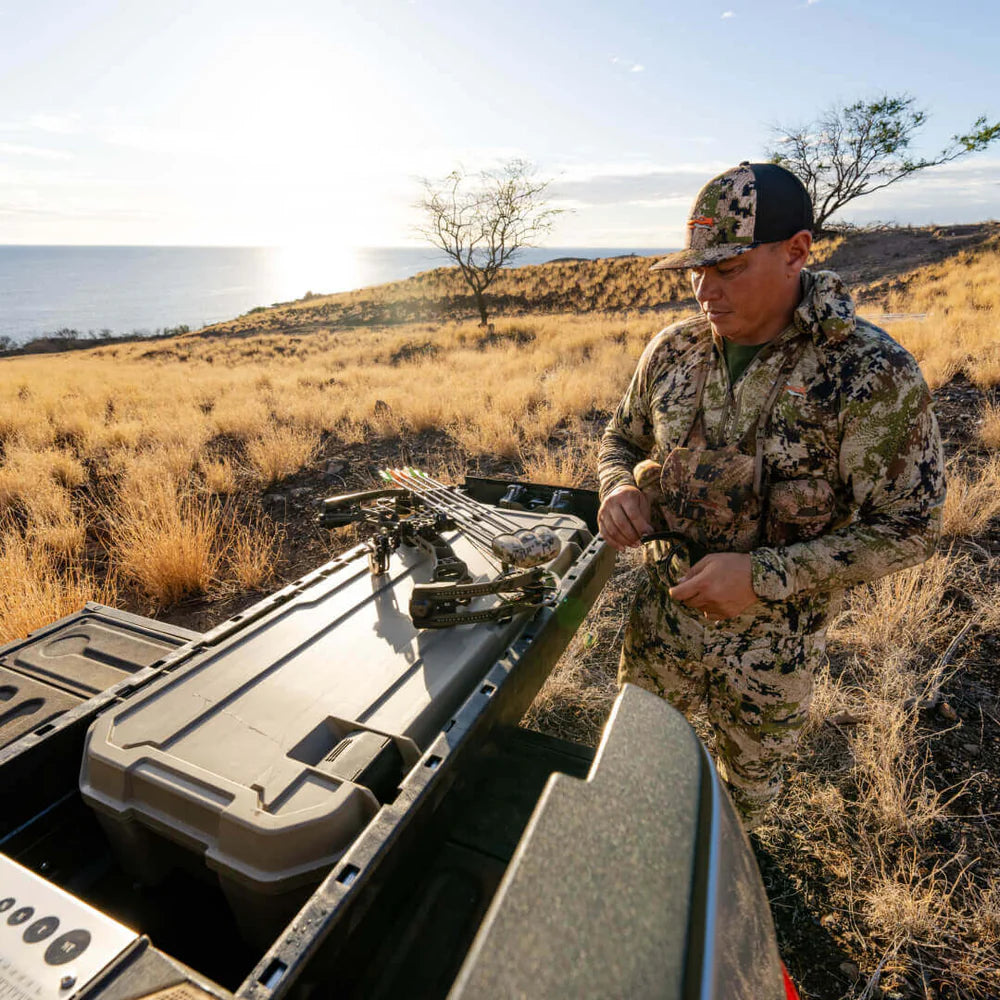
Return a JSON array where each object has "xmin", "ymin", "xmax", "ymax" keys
[{"xmin": 598, "ymin": 162, "xmax": 944, "ymax": 829}]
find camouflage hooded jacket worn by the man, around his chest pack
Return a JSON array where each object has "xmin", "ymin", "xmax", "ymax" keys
[{"xmin": 599, "ymin": 271, "xmax": 945, "ymax": 634}]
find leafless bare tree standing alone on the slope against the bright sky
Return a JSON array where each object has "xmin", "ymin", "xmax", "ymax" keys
[{"xmin": 416, "ymin": 159, "xmax": 561, "ymax": 326}]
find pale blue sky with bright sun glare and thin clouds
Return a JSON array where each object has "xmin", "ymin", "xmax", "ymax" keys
[{"xmin": 0, "ymin": 0, "xmax": 1000, "ymax": 247}]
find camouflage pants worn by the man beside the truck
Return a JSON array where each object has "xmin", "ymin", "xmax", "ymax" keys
[{"xmin": 618, "ymin": 576, "xmax": 826, "ymax": 829}]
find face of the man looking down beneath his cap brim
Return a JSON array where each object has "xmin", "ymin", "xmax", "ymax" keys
[{"xmin": 690, "ymin": 243, "xmax": 798, "ymax": 344}]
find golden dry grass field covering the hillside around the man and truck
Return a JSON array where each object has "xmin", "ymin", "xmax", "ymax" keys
[{"xmin": 0, "ymin": 230, "xmax": 1000, "ymax": 997}]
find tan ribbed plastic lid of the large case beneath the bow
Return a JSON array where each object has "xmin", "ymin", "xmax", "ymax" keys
[{"xmin": 81, "ymin": 512, "xmax": 590, "ymax": 892}]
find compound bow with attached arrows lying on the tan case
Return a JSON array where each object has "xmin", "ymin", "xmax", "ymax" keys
[{"xmin": 320, "ymin": 468, "xmax": 562, "ymax": 628}]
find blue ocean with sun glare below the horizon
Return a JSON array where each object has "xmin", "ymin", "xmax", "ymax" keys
[{"xmin": 0, "ymin": 246, "xmax": 668, "ymax": 343}]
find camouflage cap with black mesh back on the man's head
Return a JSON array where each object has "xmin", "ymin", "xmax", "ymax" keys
[{"xmin": 650, "ymin": 160, "xmax": 813, "ymax": 271}]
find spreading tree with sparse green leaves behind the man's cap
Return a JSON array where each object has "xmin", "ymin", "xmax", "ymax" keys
[{"xmin": 767, "ymin": 94, "xmax": 1000, "ymax": 232}]
